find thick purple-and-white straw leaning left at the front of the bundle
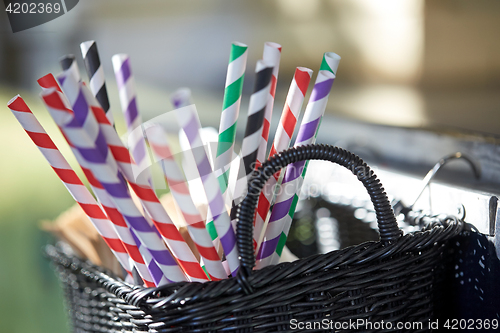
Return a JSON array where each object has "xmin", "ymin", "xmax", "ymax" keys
[{"xmin": 42, "ymin": 76, "xmax": 185, "ymax": 281}]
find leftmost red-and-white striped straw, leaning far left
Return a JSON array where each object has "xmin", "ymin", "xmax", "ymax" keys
[{"xmin": 7, "ymin": 95, "xmax": 131, "ymax": 275}]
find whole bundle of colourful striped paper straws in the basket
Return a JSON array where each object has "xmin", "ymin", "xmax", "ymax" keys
[{"xmin": 8, "ymin": 41, "xmax": 340, "ymax": 287}]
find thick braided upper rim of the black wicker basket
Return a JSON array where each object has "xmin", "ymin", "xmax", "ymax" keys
[{"xmin": 45, "ymin": 216, "xmax": 464, "ymax": 311}]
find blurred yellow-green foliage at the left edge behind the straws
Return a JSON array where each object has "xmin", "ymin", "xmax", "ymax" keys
[{"xmin": 0, "ymin": 87, "xmax": 73, "ymax": 333}]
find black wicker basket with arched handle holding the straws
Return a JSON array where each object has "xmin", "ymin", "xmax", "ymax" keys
[{"xmin": 47, "ymin": 145, "xmax": 463, "ymax": 332}]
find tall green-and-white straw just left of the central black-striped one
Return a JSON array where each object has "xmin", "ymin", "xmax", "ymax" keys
[{"xmin": 207, "ymin": 42, "xmax": 248, "ymax": 240}]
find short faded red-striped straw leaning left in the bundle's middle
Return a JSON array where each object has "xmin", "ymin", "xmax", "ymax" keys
[{"xmin": 145, "ymin": 125, "xmax": 227, "ymax": 280}]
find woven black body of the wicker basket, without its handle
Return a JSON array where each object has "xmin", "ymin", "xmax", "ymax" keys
[{"xmin": 48, "ymin": 215, "xmax": 461, "ymax": 332}]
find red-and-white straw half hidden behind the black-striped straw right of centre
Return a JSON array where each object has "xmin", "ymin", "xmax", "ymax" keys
[{"xmin": 257, "ymin": 42, "xmax": 281, "ymax": 167}]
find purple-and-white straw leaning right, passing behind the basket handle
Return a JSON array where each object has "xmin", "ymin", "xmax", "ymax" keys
[{"xmin": 256, "ymin": 71, "xmax": 335, "ymax": 268}]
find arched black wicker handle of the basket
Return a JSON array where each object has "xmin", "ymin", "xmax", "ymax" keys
[{"xmin": 236, "ymin": 144, "xmax": 403, "ymax": 293}]
